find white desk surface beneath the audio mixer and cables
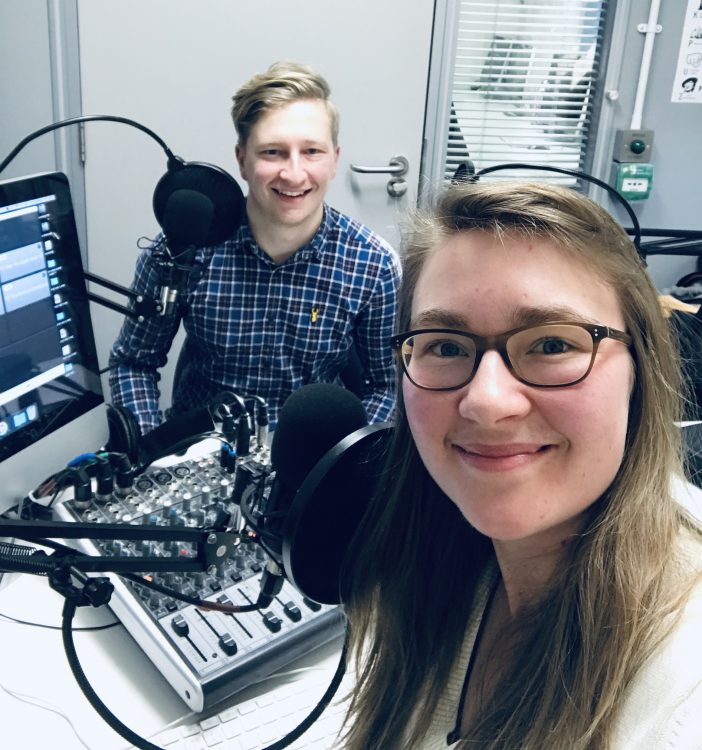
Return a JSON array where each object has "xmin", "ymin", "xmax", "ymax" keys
[{"xmin": 0, "ymin": 574, "xmax": 340, "ymax": 750}]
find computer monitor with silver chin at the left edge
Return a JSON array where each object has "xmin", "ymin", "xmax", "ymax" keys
[{"xmin": 0, "ymin": 172, "xmax": 108, "ymax": 514}]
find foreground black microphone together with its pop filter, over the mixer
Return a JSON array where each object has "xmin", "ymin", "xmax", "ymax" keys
[{"xmin": 241, "ymin": 383, "xmax": 392, "ymax": 604}]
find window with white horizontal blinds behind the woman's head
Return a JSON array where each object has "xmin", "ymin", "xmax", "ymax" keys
[{"xmin": 427, "ymin": 0, "xmax": 611, "ymax": 187}]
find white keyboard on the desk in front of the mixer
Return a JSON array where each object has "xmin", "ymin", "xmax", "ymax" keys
[{"xmin": 140, "ymin": 652, "xmax": 353, "ymax": 750}]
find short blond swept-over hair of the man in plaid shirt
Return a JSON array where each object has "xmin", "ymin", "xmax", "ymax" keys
[{"xmin": 232, "ymin": 61, "xmax": 339, "ymax": 146}]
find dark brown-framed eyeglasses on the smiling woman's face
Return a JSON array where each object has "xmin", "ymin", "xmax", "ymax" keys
[{"xmin": 390, "ymin": 323, "xmax": 632, "ymax": 391}]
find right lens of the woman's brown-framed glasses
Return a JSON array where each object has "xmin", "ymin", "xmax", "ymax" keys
[{"xmin": 507, "ymin": 324, "xmax": 593, "ymax": 385}]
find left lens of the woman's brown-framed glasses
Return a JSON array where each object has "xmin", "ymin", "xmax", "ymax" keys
[{"xmin": 401, "ymin": 333, "xmax": 475, "ymax": 388}]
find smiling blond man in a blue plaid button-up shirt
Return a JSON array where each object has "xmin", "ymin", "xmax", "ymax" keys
[{"xmin": 110, "ymin": 63, "xmax": 400, "ymax": 433}]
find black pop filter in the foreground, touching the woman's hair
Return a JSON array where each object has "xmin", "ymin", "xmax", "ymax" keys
[{"xmin": 282, "ymin": 422, "xmax": 392, "ymax": 604}]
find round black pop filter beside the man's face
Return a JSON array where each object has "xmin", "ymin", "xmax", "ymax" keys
[{"xmin": 153, "ymin": 159, "xmax": 246, "ymax": 245}]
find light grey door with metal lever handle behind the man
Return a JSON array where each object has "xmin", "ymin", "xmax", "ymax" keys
[{"xmin": 78, "ymin": 0, "xmax": 434, "ymax": 394}]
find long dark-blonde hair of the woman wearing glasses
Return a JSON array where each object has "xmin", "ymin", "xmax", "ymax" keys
[{"xmin": 345, "ymin": 182, "xmax": 699, "ymax": 750}]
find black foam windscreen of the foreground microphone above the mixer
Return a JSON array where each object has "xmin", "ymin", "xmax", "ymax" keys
[{"xmin": 271, "ymin": 383, "xmax": 368, "ymax": 490}]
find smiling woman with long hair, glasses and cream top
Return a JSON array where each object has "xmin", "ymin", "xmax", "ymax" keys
[{"xmin": 344, "ymin": 183, "xmax": 702, "ymax": 750}]
